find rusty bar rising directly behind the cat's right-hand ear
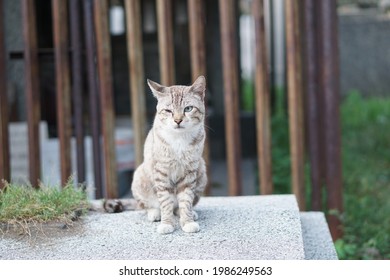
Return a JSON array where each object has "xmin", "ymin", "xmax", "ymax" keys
[{"xmin": 188, "ymin": 0, "xmax": 211, "ymax": 194}]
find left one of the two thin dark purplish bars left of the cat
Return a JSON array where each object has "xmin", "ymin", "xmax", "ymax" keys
[{"xmin": 70, "ymin": 0, "xmax": 85, "ymax": 183}]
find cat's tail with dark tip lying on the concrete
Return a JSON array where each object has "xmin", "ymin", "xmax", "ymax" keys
[{"xmin": 91, "ymin": 198, "xmax": 140, "ymax": 213}]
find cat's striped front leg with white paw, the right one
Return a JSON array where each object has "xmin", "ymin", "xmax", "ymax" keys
[{"xmin": 177, "ymin": 186, "xmax": 199, "ymax": 233}]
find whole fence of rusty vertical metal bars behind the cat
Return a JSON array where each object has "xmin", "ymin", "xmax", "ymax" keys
[{"xmin": 0, "ymin": 0, "xmax": 342, "ymax": 238}]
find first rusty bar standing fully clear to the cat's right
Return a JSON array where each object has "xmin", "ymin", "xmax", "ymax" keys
[{"xmin": 219, "ymin": 0, "xmax": 241, "ymax": 195}]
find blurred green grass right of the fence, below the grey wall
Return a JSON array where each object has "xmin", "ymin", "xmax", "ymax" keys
[{"xmin": 336, "ymin": 92, "xmax": 390, "ymax": 259}]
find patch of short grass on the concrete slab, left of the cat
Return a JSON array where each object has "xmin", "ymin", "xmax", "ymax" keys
[{"xmin": 0, "ymin": 182, "xmax": 88, "ymax": 229}]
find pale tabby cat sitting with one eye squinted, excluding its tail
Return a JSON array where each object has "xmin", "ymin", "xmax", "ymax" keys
[{"xmin": 131, "ymin": 76, "xmax": 207, "ymax": 234}]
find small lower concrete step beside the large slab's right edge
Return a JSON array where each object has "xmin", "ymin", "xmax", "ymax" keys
[{"xmin": 301, "ymin": 212, "xmax": 338, "ymax": 260}]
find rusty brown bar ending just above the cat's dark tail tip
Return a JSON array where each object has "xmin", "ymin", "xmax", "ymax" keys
[{"xmin": 94, "ymin": 0, "xmax": 118, "ymax": 198}]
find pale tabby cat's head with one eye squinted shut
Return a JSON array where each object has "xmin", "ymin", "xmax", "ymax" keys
[{"xmin": 148, "ymin": 76, "xmax": 206, "ymax": 132}]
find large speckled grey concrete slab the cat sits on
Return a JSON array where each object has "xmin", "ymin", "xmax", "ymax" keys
[{"xmin": 0, "ymin": 195, "xmax": 305, "ymax": 260}]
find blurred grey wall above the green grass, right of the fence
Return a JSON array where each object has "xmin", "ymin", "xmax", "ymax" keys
[{"xmin": 339, "ymin": 13, "xmax": 390, "ymax": 96}]
